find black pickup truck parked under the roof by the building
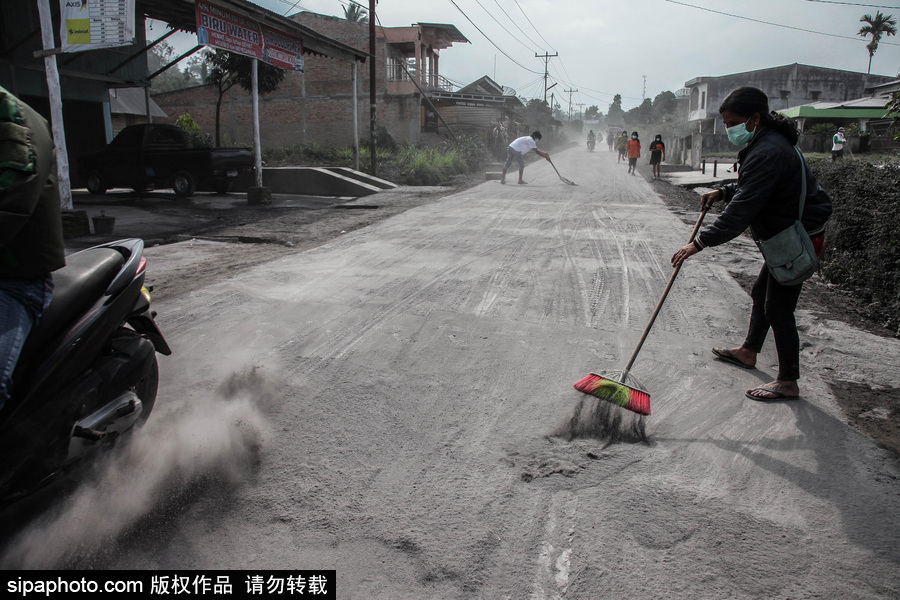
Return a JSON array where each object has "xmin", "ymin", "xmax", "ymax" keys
[{"xmin": 78, "ymin": 123, "xmax": 254, "ymax": 196}]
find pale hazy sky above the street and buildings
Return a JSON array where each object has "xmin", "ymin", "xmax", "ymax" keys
[{"xmin": 149, "ymin": 0, "xmax": 900, "ymax": 113}]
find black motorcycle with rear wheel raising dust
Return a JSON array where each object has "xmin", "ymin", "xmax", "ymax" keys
[{"xmin": 0, "ymin": 239, "xmax": 172, "ymax": 507}]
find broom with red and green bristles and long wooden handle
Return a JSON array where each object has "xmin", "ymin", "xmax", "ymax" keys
[{"xmin": 575, "ymin": 209, "xmax": 707, "ymax": 415}]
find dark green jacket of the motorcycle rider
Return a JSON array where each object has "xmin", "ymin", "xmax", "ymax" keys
[{"xmin": 0, "ymin": 87, "xmax": 66, "ymax": 279}]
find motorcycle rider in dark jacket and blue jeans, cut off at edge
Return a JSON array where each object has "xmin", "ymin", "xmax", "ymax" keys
[{"xmin": 0, "ymin": 87, "xmax": 65, "ymax": 407}]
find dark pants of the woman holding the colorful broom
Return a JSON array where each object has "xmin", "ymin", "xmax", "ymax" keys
[{"xmin": 744, "ymin": 264, "xmax": 803, "ymax": 381}]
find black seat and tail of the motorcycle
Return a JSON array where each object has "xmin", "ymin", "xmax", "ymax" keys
[{"xmin": 20, "ymin": 248, "xmax": 125, "ymax": 362}]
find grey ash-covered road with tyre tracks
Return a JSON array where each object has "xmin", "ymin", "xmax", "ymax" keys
[{"xmin": 8, "ymin": 149, "xmax": 900, "ymax": 599}]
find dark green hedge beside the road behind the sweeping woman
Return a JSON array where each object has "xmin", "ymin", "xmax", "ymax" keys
[{"xmin": 811, "ymin": 160, "xmax": 900, "ymax": 334}]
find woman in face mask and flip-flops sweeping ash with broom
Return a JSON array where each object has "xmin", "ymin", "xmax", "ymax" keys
[{"xmin": 672, "ymin": 87, "xmax": 831, "ymax": 400}]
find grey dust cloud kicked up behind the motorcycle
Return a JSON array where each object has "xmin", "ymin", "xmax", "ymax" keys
[{"xmin": 0, "ymin": 366, "xmax": 273, "ymax": 569}]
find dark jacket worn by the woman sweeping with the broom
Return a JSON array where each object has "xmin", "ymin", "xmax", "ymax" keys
[{"xmin": 697, "ymin": 128, "xmax": 831, "ymax": 248}]
